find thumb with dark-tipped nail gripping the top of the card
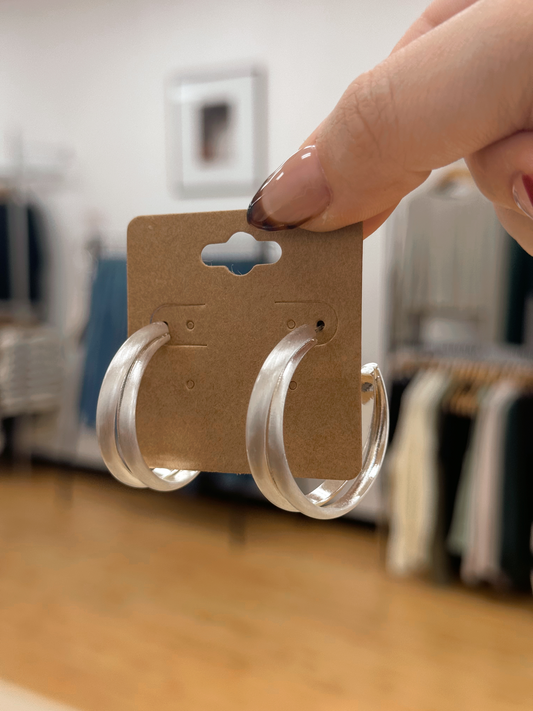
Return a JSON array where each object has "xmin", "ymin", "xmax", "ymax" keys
[{"xmin": 248, "ymin": 0, "xmax": 533, "ymax": 236}]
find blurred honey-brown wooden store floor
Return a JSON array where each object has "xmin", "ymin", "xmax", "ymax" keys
[{"xmin": 0, "ymin": 470, "xmax": 533, "ymax": 711}]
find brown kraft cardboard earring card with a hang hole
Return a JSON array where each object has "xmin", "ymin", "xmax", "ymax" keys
[{"xmin": 128, "ymin": 210, "xmax": 362, "ymax": 480}]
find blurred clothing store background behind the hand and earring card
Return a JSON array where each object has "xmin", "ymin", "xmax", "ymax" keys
[{"xmin": 0, "ymin": 0, "xmax": 533, "ymax": 711}]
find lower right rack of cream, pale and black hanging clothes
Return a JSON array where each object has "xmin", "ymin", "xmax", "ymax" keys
[{"xmin": 386, "ymin": 347, "xmax": 533, "ymax": 592}]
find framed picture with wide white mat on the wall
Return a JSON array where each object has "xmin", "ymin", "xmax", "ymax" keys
[{"xmin": 167, "ymin": 68, "xmax": 267, "ymax": 197}]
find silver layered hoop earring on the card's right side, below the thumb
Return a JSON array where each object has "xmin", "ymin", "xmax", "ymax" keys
[{"xmin": 246, "ymin": 325, "xmax": 389, "ymax": 519}]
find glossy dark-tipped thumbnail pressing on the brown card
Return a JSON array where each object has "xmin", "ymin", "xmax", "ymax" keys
[{"xmin": 247, "ymin": 146, "xmax": 331, "ymax": 230}]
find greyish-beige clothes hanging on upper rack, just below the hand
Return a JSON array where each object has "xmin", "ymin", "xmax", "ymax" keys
[{"xmin": 389, "ymin": 178, "xmax": 513, "ymax": 349}]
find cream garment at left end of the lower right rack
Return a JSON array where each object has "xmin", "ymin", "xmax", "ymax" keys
[{"xmin": 387, "ymin": 371, "xmax": 450, "ymax": 574}]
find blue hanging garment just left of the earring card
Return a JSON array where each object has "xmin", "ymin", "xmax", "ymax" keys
[{"xmin": 80, "ymin": 258, "xmax": 128, "ymax": 427}]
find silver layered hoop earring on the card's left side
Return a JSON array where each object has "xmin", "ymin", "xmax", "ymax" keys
[{"xmin": 96, "ymin": 322, "xmax": 200, "ymax": 491}]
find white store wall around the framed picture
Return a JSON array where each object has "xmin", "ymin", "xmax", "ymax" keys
[{"xmin": 0, "ymin": 0, "xmax": 426, "ymax": 361}]
